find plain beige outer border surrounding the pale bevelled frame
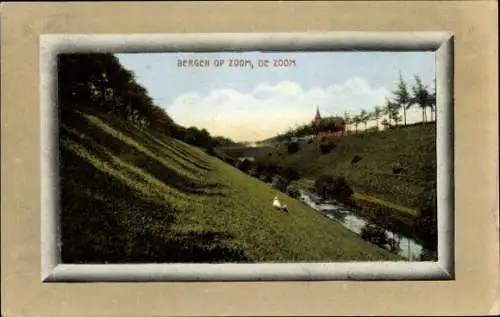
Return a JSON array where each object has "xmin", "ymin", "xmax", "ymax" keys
[{"xmin": 1, "ymin": 1, "xmax": 499, "ymax": 316}]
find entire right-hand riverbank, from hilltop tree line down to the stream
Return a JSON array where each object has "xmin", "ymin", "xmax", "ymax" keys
[{"xmin": 217, "ymin": 122, "xmax": 437, "ymax": 250}]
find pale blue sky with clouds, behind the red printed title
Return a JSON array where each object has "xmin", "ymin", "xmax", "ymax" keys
[{"xmin": 117, "ymin": 52, "xmax": 435, "ymax": 141}]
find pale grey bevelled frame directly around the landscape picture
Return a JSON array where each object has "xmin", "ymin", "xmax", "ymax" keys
[{"xmin": 40, "ymin": 32, "xmax": 455, "ymax": 282}]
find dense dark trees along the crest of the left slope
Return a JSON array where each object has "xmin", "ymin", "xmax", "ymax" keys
[{"xmin": 57, "ymin": 53, "xmax": 234, "ymax": 149}]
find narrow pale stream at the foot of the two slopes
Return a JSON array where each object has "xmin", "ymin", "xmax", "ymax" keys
[{"xmin": 300, "ymin": 191, "xmax": 424, "ymax": 261}]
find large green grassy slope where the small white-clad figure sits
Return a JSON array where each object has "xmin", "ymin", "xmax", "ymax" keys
[{"xmin": 60, "ymin": 110, "xmax": 399, "ymax": 263}]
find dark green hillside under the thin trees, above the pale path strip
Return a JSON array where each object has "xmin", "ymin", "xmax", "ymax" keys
[{"xmin": 246, "ymin": 123, "xmax": 436, "ymax": 209}]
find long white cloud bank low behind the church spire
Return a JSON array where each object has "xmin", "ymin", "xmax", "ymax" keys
[{"xmin": 167, "ymin": 78, "xmax": 426, "ymax": 141}]
